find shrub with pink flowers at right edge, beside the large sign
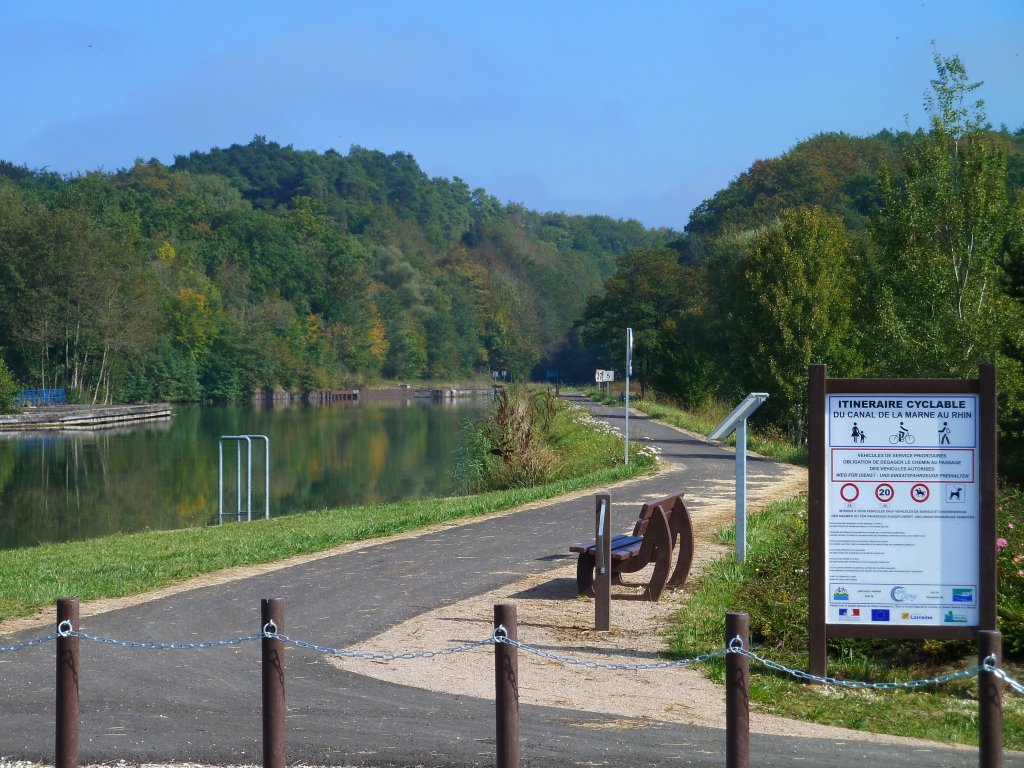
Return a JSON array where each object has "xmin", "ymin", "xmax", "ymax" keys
[{"xmin": 995, "ymin": 487, "xmax": 1024, "ymax": 658}]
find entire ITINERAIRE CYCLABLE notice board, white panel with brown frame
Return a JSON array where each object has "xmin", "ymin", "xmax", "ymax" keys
[{"xmin": 808, "ymin": 365, "xmax": 995, "ymax": 675}]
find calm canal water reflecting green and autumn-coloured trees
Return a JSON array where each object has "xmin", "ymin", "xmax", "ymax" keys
[{"xmin": 0, "ymin": 398, "xmax": 486, "ymax": 549}]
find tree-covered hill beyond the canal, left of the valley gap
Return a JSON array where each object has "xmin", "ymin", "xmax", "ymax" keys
[{"xmin": 0, "ymin": 136, "xmax": 681, "ymax": 400}]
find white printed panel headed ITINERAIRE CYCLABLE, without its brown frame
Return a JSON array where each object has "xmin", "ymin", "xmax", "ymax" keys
[{"xmin": 825, "ymin": 394, "xmax": 980, "ymax": 627}]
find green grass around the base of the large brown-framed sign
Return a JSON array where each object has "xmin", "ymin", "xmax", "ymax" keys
[{"xmin": 670, "ymin": 499, "xmax": 1024, "ymax": 750}]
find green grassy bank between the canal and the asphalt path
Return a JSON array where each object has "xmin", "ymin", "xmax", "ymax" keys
[{"xmin": 0, "ymin": 391, "xmax": 655, "ymax": 621}]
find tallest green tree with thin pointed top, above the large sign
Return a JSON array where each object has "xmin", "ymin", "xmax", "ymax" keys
[{"xmin": 872, "ymin": 54, "xmax": 1020, "ymax": 377}]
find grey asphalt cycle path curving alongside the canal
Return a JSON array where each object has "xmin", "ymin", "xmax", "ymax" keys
[{"xmin": 0, "ymin": 399, "xmax": 1007, "ymax": 768}]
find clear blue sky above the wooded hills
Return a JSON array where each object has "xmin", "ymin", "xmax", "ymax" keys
[{"xmin": 0, "ymin": 0, "xmax": 1024, "ymax": 228}]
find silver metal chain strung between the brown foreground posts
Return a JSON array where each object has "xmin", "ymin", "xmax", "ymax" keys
[{"xmin": 0, "ymin": 622, "xmax": 1024, "ymax": 695}]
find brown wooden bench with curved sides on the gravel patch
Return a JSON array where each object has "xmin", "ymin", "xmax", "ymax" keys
[{"xmin": 569, "ymin": 493, "xmax": 693, "ymax": 601}]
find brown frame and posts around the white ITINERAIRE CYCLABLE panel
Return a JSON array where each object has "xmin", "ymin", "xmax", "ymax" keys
[{"xmin": 807, "ymin": 364, "xmax": 996, "ymax": 675}]
